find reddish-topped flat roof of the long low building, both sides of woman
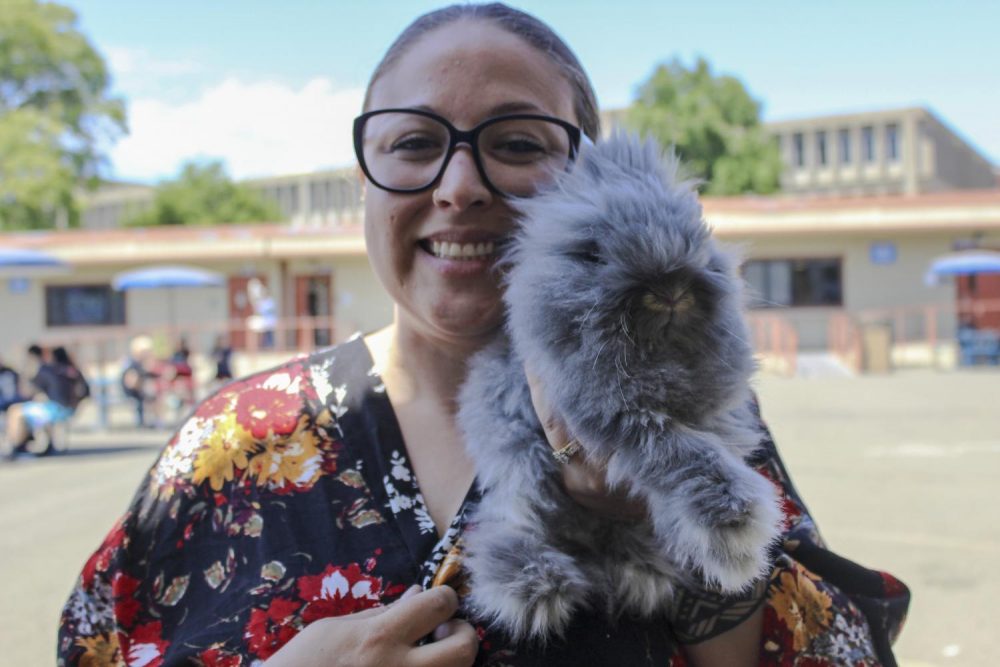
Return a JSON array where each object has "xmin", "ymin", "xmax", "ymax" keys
[{"xmin": 0, "ymin": 188, "xmax": 1000, "ymax": 266}]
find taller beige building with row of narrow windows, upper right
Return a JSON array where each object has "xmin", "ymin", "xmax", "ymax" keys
[{"xmin": 766, "ymin": 108, "xmax": 997, "ymax": 196}]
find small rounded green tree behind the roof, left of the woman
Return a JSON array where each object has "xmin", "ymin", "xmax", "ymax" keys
[{"xmin": 126, "ymin": 162, "xmax": 281, "ymax": 227}]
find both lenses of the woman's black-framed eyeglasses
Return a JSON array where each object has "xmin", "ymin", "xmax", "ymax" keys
[{"xmin": 362, "ymin": 111, "xmax": 571, "ymax": 196}]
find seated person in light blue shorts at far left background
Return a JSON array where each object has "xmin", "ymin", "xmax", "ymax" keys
[{"xmin": 6, "ymin": 347, "xmax": 90, "ymax": 456}]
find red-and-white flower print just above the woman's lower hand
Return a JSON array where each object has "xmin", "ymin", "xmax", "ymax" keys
[{"xmin": 298, "ymin": 563, "xmax": 382, "ymax": 623}]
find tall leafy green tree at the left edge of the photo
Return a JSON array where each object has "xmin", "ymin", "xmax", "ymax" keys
[{"xmin": 0, "ymin": 0, "xmax": 126, "ymax": 229}]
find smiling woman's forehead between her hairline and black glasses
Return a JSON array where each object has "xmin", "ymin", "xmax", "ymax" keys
[{"xmin": 369, "ymin": 20, "xmax": 579, "ymax": 125}]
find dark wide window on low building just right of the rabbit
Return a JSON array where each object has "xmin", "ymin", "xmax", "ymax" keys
[{"xmin": 743, "ymin": 259, "xmax": 843, "ymax": 308}]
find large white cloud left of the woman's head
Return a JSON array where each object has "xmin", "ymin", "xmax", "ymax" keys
[{"xmin": 111, "ymin": 78, "xmax": 364, "ymax": 180}]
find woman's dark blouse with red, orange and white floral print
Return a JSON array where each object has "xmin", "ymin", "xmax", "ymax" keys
[{"xmin": 58, "ymin": 338, "xmax": 909, "ymax": 667}]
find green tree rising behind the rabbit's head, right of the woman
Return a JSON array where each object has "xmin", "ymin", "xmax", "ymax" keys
[{"xmin": 625, "ymin": 58, "xmax": 782, "ymax": 195}]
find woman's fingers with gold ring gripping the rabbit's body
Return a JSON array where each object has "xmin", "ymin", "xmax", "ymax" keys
[{"xmin": 525, "ymin": 369, "xmax": 647, "ymax": 521}]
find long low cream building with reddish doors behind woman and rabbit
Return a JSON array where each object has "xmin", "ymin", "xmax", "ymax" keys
[{"xmin": 0, "ymin": 189, "xmax": 1000, "ymax": 374}]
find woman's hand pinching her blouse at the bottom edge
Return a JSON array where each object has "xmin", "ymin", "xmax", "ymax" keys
[{"xmin": 265, "ymin": 586, "xmax": 479, "ymax": 667}]
